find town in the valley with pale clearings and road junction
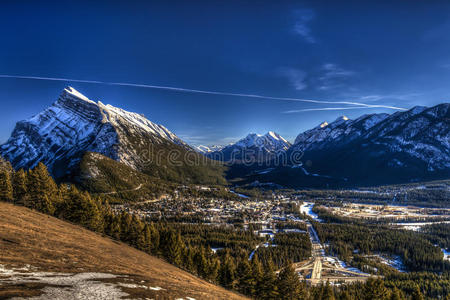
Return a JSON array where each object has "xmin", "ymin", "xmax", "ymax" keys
[{"xmin": 112, "ymin": 182, "xmax": 450, "ymax": 285}]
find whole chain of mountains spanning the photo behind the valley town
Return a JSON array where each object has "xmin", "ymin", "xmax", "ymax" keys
[{"xmin": 0, "ymin": 87, "xmax": 450, "ymax": 187}]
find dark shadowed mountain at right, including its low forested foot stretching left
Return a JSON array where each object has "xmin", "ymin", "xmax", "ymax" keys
[{"xmin": 215, "ymin": 103, "xmax": 450, "ymax": 187}]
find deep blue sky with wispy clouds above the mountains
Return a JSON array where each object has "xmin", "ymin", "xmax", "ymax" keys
[{"xmin": 0, "ymin": 1, "xmax": 450, "ymax": 145}]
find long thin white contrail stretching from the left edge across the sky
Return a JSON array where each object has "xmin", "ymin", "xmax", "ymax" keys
[{"xmin": 0, "ymin": 74, "xmax": 406, "ymax": 110}]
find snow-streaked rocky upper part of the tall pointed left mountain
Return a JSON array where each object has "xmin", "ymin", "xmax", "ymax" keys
[{"xmin": 0, "ymin": 87, "xmax": 188, "ymax": 176}]
